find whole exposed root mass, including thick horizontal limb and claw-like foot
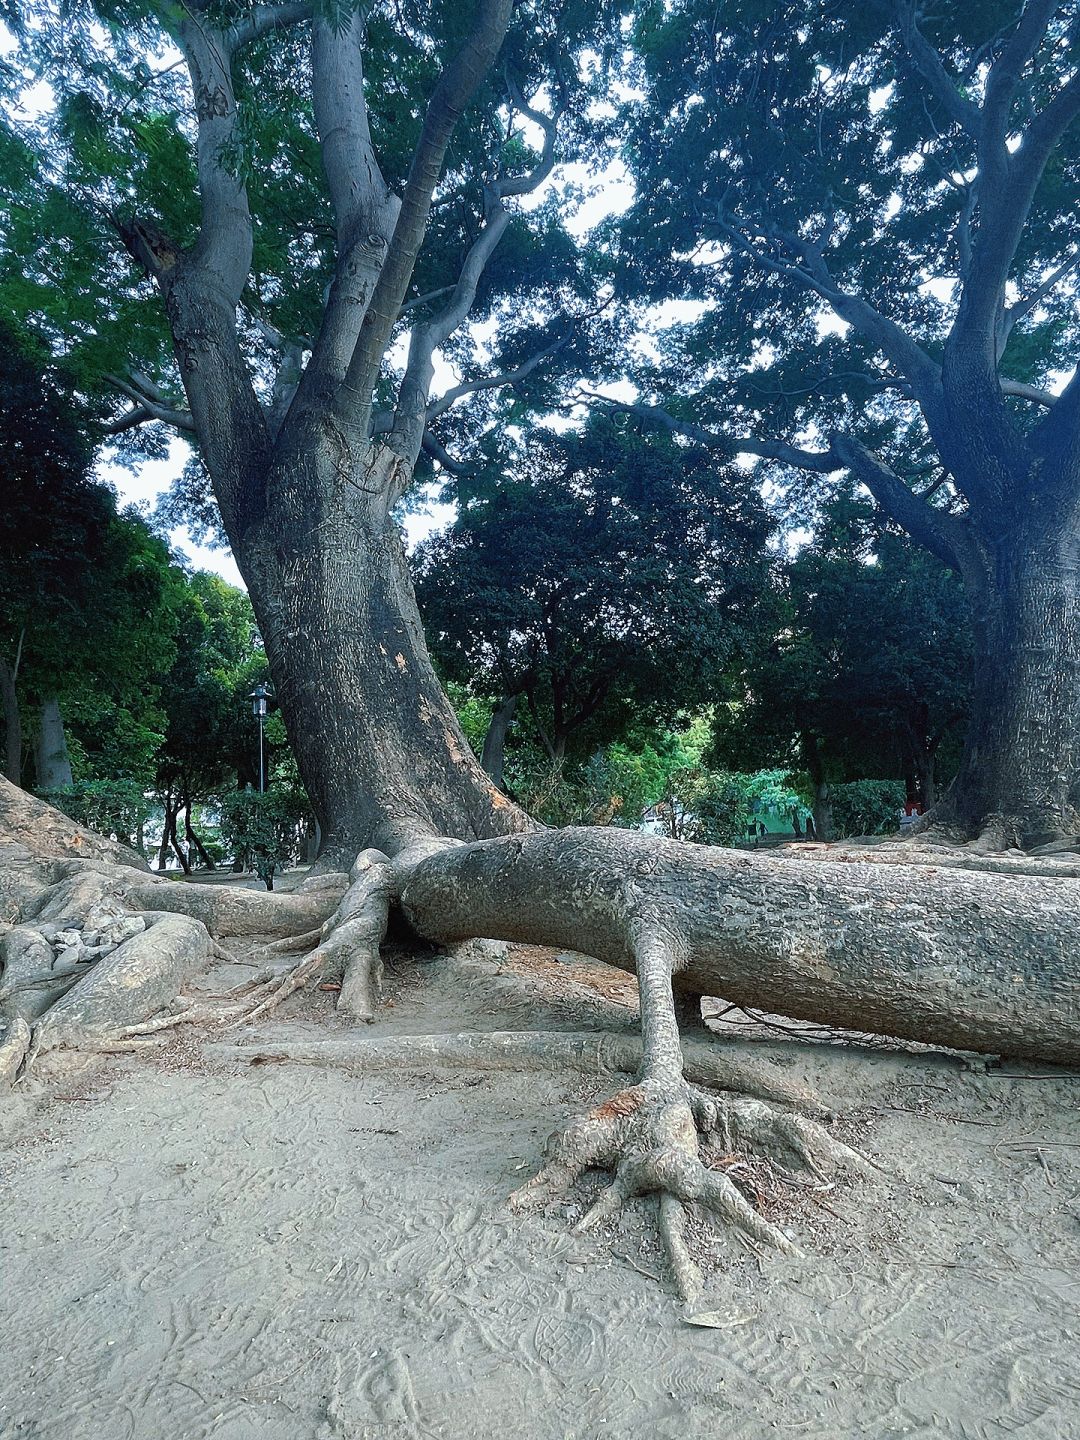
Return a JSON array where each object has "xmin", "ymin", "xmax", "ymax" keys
[{"xmin": 0, "ymin": 793, "xmax": 1080, "ymax": 1293}]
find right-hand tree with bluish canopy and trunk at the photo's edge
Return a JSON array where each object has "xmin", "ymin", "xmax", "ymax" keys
[{"xmin": 610, "ymin": 0, "xmax": 1080, "ymax": 845}]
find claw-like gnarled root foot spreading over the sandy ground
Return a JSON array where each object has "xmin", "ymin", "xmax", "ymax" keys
[{"xmin": 510, "ymin": 1080, "xmax": 876, "ymax": 1302}]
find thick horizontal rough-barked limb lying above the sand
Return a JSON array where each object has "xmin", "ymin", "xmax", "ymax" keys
[{"xmin": 402, "ymin": 829, "xmax": 1080, "ymax": 1064}]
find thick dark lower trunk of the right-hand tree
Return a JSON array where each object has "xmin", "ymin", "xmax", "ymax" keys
[{"xmin": 942, "ymin": 538, "xmax": 1080, "ymax": 850}]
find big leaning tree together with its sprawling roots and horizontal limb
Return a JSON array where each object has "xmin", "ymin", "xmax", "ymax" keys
[{"xmin": 0, "ymin": 0, "xmax": 1080, "ymax": 1293}]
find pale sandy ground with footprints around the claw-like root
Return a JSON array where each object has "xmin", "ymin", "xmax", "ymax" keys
[{"xmin": 0, "ymin": 927, "xmax": 1080, "ymax": 1440}]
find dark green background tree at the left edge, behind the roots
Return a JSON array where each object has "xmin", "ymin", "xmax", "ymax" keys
[{"xmin": 0, "ymin": 316, "xmax": 183, "ymax": 789}]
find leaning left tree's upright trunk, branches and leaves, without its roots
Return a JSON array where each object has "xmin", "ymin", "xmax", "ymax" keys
[{"xmin": 2, "ymin": 0, "xmax": 616, "ymax": 854}]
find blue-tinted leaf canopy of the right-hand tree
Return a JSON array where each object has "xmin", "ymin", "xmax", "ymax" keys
[{"xmin": 612, "ymin": 0, "xmax": 1080, "ymax": 495}]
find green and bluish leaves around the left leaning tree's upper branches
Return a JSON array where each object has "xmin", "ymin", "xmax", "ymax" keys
[{"xmin": 0, "ymin": 0, "xmax": 626, "ymax": 478}]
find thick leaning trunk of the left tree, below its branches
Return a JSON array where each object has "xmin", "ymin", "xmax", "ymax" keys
[{"xmin": 232, "ymin": 428, "xmax": 528, "ymax": 863}]
